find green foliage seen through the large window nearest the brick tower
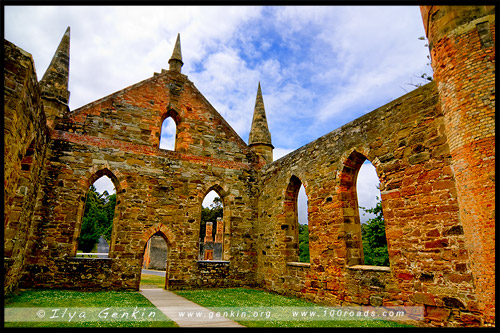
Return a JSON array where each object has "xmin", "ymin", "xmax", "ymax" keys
[{"xmin": 360, "ymin": 197, "xmax": 389, "ymax": 266}]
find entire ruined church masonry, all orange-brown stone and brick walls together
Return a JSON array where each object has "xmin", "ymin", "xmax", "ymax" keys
[{"xmin": 4, "ymin": 6, "xmax": 495, "ymax": 326}]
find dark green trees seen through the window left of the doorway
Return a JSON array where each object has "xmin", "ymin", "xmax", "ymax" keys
[{"xmin": 78, "ymin": 185, "xmax": 116, "ymax": 252}]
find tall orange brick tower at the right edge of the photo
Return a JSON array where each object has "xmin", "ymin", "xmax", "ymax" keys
[{"xmin": 421, "ymin": 6, "xmax": 495, "ymax": 323}]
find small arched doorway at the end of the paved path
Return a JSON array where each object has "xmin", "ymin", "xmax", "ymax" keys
[{"xmin": 140, "ymin": 232, "xmax": 168, "ymax": 288}]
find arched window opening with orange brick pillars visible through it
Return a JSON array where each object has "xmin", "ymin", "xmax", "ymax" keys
[{"xmin": 199, "ymin": 190, "xmax": 224, "ymax": 260}]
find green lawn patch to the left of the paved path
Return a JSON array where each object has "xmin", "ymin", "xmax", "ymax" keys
[{"xmin": 4, "ymin": 289, "xmax": 177, "ymax": 327}]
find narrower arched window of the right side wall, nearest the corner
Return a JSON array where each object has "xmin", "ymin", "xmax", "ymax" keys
[{"xmin": 281, "ymin": 176, "xmax": 309, "ymax": 262}]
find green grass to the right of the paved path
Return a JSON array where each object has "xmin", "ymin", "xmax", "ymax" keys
[{"xmin": 175, "ymin": 288, "xmax": 412, "ymax": 327}]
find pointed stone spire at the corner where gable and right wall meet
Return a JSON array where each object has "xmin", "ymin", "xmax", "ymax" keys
[{"xmin": 248, "ymin": 82, "xmax": 274, "ymax": 163}]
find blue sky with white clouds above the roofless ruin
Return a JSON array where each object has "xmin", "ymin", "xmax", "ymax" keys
[{"xmin": 4, "ymin": 6, "xmax": 430, "ymax": 222}]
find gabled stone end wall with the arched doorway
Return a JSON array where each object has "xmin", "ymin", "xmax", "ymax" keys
[{"xmin": 18, "ymin": 67, "xmax": 260, "ymax": 289}]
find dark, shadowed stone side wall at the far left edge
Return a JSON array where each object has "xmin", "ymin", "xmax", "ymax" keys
[{"xmin": 3, "ymin": 41, "xmax": 48, "ymax": 293}]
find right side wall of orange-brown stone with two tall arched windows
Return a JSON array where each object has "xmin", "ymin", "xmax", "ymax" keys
[{"xmin": 257, "ymin": 83, "xmax": 480, "ymax": 325}]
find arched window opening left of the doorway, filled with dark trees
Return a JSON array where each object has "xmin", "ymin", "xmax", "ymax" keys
[{"xmin": 77, "ymin": 175, "xmax": 116, "ymax": 258}]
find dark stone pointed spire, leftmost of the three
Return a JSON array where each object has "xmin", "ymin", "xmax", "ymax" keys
[{"xmin": 40, "ymin": 27, "xmax": 70, "ymax": 104}]
